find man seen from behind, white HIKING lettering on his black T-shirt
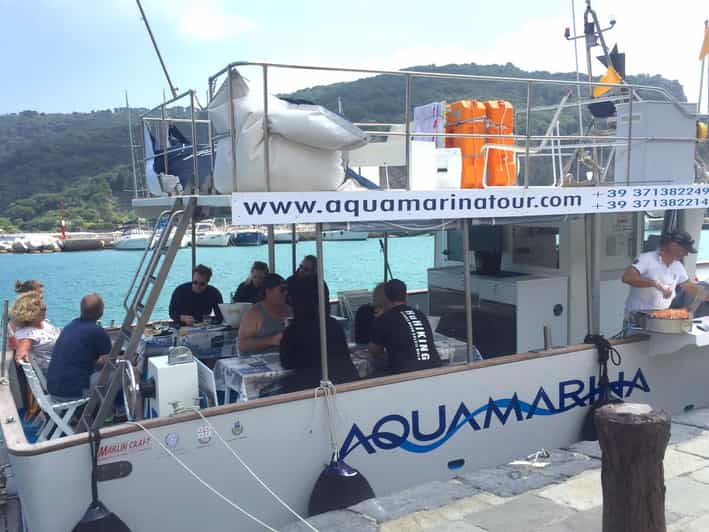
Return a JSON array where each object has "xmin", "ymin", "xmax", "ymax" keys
[{"xmin": 369, "ymin": 279, "xmax": 441, "ymax": 373}]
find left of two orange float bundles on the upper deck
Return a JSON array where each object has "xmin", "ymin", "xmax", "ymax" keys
[{"xmin": 446, "ymin": 100, "xmax": 486, "ymax": 188}]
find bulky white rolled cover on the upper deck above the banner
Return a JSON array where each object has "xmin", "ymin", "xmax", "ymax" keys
[{"xmin": 209, "ymin": 71, "xmax": 367, "ymax": 194}]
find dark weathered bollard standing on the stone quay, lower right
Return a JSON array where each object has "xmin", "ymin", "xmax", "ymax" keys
[{"xmin": 595, "ymin": 403, "xmax": 670, "ymax": 532}]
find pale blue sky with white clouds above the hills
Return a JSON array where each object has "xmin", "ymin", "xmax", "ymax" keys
[{"xmin": 0, "ymin": 0, "xmax": 709, "ymax": 114}]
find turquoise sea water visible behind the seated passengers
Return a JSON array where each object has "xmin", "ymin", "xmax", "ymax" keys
[{"xmin": 0, "ymin": 236, "xmax": 433, "ymax": 327}]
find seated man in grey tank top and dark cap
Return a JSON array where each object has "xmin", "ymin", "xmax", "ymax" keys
[{"xmin": 237, "ymin": 273, "xmax": 290, "ymax": 355}]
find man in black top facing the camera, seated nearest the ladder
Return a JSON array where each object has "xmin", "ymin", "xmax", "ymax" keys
[{"xmin": 170, "ymin": 264, "xmax": 224, "ymax": 325}]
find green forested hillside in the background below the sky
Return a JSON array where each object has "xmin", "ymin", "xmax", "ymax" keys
[{"xmin": 0, "ymin": 63, "xmax": 685, "ymax": 230}]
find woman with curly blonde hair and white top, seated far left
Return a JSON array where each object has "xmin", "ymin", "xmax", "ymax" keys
[{"xmin": 10, "ymin": 290, "xmax": 61, "ymax": 375}]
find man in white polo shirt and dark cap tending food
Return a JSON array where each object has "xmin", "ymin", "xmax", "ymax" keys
[{"xmin": 623, "ymin": 230, "xmax": 699, "ymax": 315}]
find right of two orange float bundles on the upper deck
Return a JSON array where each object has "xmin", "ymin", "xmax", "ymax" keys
[{"xmin": 485, "ymin": 100, "xmax": 517, "ymax": 187}]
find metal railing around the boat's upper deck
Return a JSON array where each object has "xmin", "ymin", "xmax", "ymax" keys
[{"xmin": 140, "ymin": 61, "xmax": 706, "ymax": 198}]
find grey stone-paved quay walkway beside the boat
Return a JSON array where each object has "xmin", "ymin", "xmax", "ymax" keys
[{"xmin": 282, "ymin": 409, "xmax": 709, "ymax": 532}]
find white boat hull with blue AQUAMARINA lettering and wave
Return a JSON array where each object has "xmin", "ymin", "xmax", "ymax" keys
[{"xmin": 5, "ymin": 340, "xmax": 709, "ymax": 532}]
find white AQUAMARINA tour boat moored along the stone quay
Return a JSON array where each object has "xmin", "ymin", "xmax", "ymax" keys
[{"xmin": 0, "ymin": 6, "xmax": 709, "ymax": 532}]
